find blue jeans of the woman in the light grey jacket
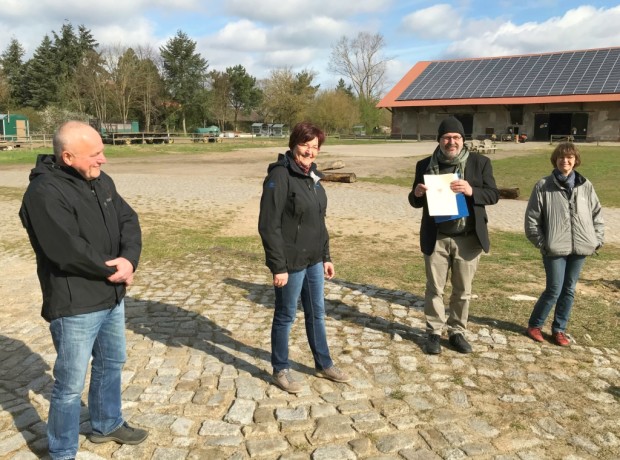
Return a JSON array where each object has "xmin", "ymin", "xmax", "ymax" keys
[{"xmin": 529, "ymin": 255, "xmax": 586, "ymax": 333}]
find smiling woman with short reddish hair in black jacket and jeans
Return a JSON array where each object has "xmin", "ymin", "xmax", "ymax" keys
[{"xmin": 258, "ymin": 122, "xmax": 350, "ymax": 393}]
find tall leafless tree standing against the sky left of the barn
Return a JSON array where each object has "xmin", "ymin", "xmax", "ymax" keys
[{"xmin": 327, "ymin": 32, "xmax": 388, "ymax": 100}]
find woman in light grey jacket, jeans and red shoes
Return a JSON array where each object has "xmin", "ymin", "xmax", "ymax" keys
[{"xmin": 525, "ymin": 142, "xmax": 604, "ymax": 346}]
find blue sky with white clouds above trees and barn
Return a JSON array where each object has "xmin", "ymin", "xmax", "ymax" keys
[{"xmin": 0, "ymin": 0, "xmax": 620, "ymax": 95}]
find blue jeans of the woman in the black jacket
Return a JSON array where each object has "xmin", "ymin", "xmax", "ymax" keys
[{"xmin": 271, "ymin": 262, "xmax": 334, "ymax": 372}]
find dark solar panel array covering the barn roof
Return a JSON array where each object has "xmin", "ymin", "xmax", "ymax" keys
[{"xmin": 396, "ymin": 48, "xmax": 620, "ymax": 101}]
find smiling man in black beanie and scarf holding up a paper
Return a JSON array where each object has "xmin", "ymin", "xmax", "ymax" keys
[{"xmin": 409, "ymin": 117, "xmax": 499, "ymax": 354}]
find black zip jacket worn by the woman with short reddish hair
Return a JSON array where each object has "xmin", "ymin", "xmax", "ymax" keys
[{"xmin": 258, "ymin": 151, "xmax": 331, "ymax": 274}]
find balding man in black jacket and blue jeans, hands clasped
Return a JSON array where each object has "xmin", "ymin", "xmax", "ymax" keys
[{"xmin": 19, "ymin": 121, "xmax": 148, "ymax": 459}]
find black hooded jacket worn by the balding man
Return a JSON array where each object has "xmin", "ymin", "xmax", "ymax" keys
[{"xmin": 19, "ymin": 155, "xmax": 142, "ymax": 321}]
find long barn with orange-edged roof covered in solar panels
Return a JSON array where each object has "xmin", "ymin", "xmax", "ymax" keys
[{"xmin": 377, "ymin": 48, "xmax": 620, "ymax": 141}]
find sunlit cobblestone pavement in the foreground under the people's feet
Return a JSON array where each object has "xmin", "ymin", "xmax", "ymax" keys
[{"xmin": 0, "ymin": 146, "xmax": 620, "ymax": 460}]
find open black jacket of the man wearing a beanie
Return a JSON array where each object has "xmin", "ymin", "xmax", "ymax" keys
[{"xmin": 409, "ymin": 152, "xmax": 499, "ymax": 255}]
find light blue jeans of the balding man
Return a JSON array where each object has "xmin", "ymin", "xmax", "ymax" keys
[{"xmin": 47, "ymin": 300, "xmax": 126, "ymax": 459}]
